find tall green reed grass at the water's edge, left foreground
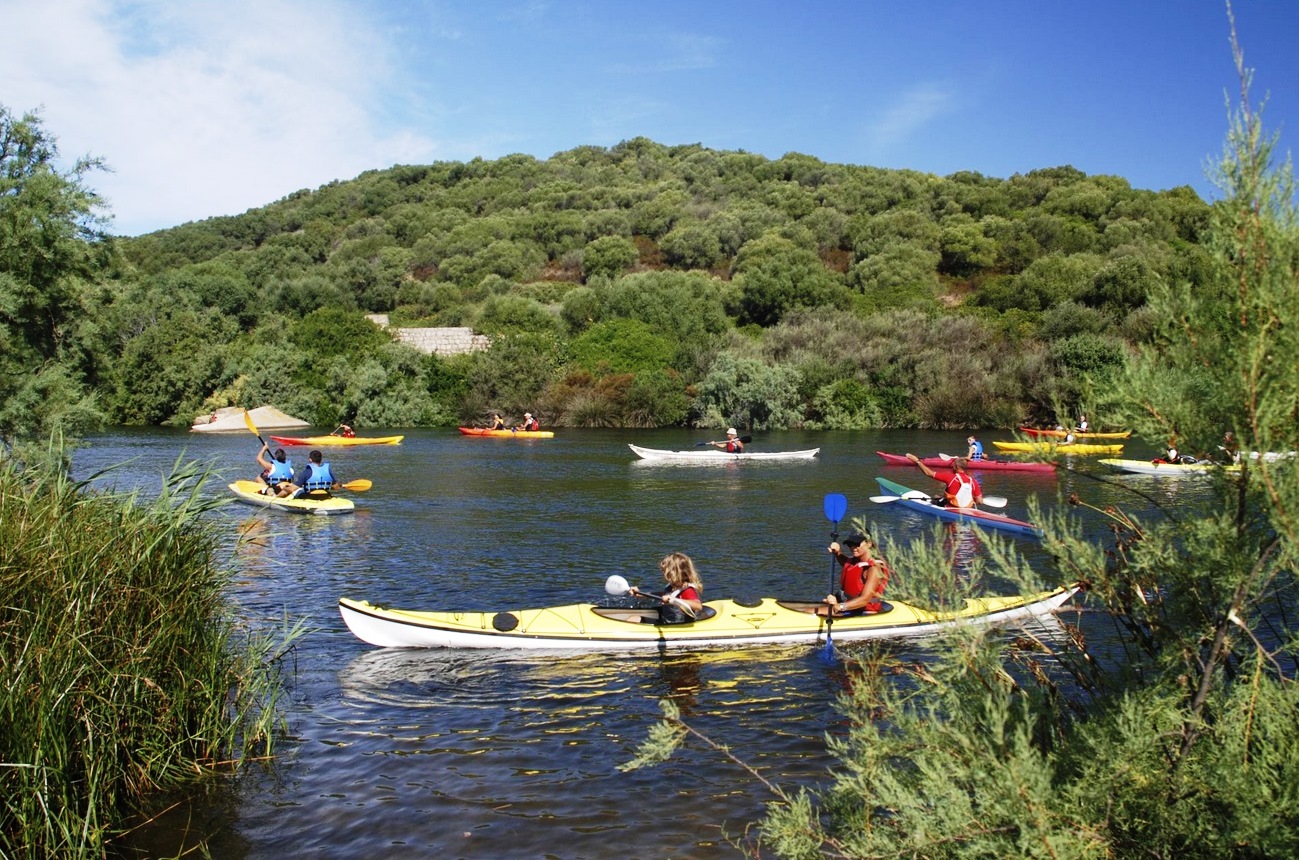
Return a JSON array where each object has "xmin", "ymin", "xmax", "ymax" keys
[{"xmin": 0, "ymin": 464, "xmax": 296, "ymax": 857}]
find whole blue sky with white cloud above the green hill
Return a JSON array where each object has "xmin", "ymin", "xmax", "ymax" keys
[{"xmin": 0, "ymin": 0, "xmax": 1299, "ymax": 235}]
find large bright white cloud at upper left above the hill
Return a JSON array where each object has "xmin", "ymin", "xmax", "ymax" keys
[{"xmin": 0, "ymin": 0, "xmax": 436, "ymax": 234}]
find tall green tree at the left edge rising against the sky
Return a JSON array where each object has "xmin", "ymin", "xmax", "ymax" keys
[{"xmin": 0, "ymin": 105, "xmax": 110, "ymax": 439}]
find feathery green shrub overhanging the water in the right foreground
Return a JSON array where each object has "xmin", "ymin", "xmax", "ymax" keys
[{"xmin": 628, "ymin": 30, "xmax": 1299, "ymax": 860}]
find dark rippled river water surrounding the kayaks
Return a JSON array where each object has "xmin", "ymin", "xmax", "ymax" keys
[{"xmin": 74, "ymin": 429, "xmax": 1194, "ymax": 860}]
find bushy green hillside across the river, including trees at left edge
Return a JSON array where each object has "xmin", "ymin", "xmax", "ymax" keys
[{"xmin": 0, "ymin": 91, "xmax": 1211, "ymax": 435}]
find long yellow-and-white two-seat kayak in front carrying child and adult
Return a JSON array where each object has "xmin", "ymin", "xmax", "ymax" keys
[{"xmin": 338, "ymin": 585, "xmax": 1079, "ymax": 651}]
